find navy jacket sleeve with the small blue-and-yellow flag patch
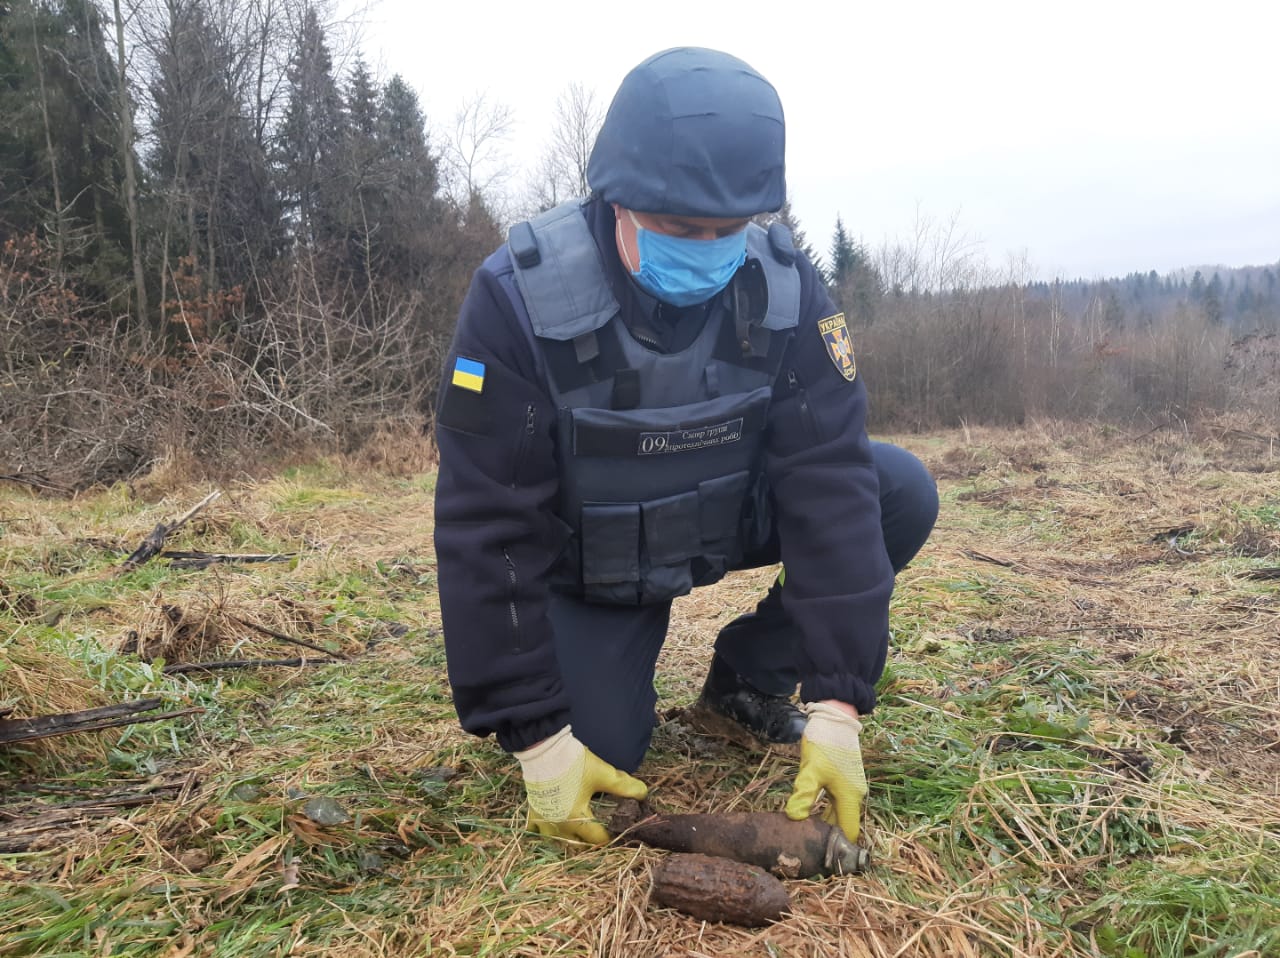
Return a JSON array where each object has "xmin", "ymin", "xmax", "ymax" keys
[{"xmin": 435, "ymin": 254, "xmax": 568, "ymax": 751}]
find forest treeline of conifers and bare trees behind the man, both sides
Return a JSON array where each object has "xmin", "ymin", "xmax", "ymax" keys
[{"xmin": 0, "ymin": 0, "xmax": 1280, "ymax": 487}]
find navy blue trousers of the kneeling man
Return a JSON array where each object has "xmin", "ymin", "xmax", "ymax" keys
[{"xmin": 549, "ymin": 442, "xmax": 938, "ymax": 772}]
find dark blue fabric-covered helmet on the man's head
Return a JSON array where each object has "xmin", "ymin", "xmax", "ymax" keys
[{"xmin": 586, "ymin": 46, "xmax": 786, "ymax": 218}]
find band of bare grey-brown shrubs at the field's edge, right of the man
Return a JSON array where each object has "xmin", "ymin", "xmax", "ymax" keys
[{"xmin": 858, "ymin": 219, "xmax": 1244, "ymax": 429}]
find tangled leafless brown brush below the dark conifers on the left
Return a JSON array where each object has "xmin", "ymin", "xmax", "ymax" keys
[{"xmin": 0, "ymin": 231, "xmax": 452, "ymax": 488}]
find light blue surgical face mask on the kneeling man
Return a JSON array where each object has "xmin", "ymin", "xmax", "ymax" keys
[{"xmin": 622, "ymin": 210, "xmax": 746, "ymax": 306}]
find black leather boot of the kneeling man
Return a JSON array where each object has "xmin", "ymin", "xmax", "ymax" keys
[{"xmin": 689, "ymin": 656, "xmax": 808, "ymax": 745}]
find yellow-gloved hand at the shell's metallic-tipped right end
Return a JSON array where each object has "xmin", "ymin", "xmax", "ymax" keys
[{"xmin": 787, "ymin": 702, "xmax": 867, "ymax": 841}]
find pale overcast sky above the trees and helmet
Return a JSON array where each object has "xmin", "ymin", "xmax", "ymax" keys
[{"xmin": 345, "ymin": 0, "xmax": 1280, "ymax": 278}]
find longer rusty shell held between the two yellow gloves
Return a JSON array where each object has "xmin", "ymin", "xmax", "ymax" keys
[{"xmin": 609, "ymin": 800, "xmax": 869, "ymax": 879}]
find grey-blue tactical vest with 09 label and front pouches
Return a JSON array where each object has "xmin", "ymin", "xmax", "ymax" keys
[{"xmin": 508, "ymin": 201, "xmax": 800, "ymax": 605}]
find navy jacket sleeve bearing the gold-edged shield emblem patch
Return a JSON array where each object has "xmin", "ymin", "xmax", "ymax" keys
[{"xmin": 765, "ymin": 257, "xmax": 893, "ymax": 713}]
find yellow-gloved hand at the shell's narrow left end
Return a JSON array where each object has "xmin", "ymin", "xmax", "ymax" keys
[{"xmin": 516, "ymin": 725, "xmax": 649, "ymax": 845}]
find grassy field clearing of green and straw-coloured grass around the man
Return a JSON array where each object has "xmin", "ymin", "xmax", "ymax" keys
[{"xmin": 0, "ymin": 425, "xmax": 1280, "ymax": 958}]
